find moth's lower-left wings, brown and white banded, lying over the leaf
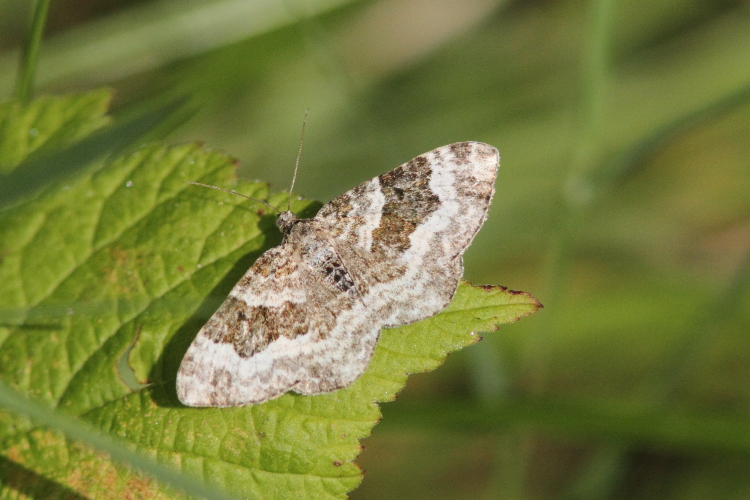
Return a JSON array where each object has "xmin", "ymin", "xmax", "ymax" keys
[{"xmin": 177, "ymin": 237, "xmax": 380, "ymax": 407}]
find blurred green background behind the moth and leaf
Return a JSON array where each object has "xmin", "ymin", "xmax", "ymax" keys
[{"xmin": 0, "ymin": 0, "xmax": 750, "ymax": 500}]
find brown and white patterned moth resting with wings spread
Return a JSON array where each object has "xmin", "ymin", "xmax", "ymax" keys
[{"xmin": 177, "ymin": 142, "xmax": 500, "ymax": 407}]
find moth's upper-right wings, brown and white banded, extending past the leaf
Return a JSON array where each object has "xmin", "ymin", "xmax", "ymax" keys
[{"xmin": 315, "ymin": 142, "xmax": 500, "ymax": 326}]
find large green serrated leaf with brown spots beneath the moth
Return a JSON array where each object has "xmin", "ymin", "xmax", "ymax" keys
[{"xmin": 0, "ymin": 93, "xmax": 540, "ymax": 499}]
